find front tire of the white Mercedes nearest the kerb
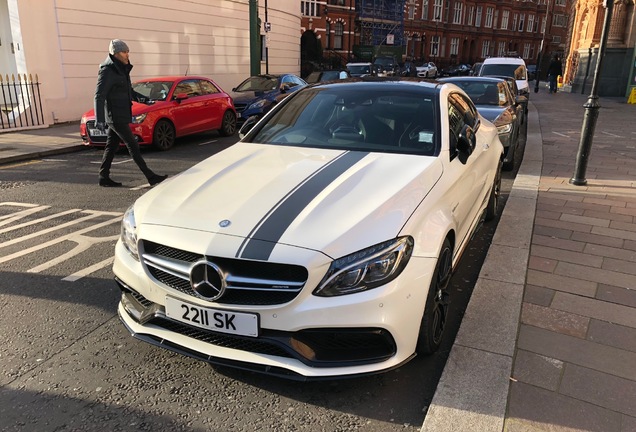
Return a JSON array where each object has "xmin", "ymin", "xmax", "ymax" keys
[{"xmin": 416, "ymin": 239, "xmax": 453, "ymax": 355}]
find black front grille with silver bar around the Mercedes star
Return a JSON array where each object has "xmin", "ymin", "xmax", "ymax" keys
[{"xmin": 142, "ymin": 240, "xmax": 308, "ymax": 306}]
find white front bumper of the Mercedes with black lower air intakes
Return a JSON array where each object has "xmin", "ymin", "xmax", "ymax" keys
[{"xmin": 114, "ymin": 236, "xmax": 435, "ymax": 380}]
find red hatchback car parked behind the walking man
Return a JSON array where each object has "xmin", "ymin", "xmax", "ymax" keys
[{"xmin": 80, "ymin": 76, "xmax": 236, "ymax": 150}]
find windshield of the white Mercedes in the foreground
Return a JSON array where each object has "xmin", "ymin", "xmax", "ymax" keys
[{"xmin": 244, "ymin": 86, "xmax": 439, "ymax": 156}]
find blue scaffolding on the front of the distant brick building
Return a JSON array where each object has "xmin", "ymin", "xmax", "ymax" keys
[{"xmin": 357, "ymin": 0, "xmax": 404, "ymax": 47}]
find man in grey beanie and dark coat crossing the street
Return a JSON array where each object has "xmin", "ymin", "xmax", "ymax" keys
[{"xmin": 94, "ymin": 39, "xmax": 168, "ymax": 187}]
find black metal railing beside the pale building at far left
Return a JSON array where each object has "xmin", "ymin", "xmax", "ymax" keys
[{"xmin": 0, "ymin": 74, "xmax": 45, "ymax": 130}]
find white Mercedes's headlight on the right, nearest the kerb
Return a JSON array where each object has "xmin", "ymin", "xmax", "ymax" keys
[{"xmin": 314, "ymin": 237, "xmax": 413, "ymax": 297}]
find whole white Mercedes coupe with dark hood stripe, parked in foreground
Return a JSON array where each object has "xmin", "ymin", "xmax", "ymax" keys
[{"xmin": 113, "ymin": 78, "xmax": 503, "ymax": 380}]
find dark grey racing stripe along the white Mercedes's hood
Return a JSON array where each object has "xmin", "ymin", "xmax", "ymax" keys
[{"xmin": 237, "ymin": 152, "xmax": 368, "ymax": 261}]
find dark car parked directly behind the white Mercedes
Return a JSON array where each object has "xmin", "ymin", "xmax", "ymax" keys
[{"xmin": 439, "ymin": 77, "xmax": 524, "ymax": 170}]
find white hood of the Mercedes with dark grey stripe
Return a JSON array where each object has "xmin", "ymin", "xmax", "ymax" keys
[{"xmin": 135, "ymin": 143, "xmax": 442, "ymax": 260}]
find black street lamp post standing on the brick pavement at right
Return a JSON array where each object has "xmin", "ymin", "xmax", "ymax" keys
[{"xmin": 570, "ymin": 0, "xmax": 614, "ymax": 186}]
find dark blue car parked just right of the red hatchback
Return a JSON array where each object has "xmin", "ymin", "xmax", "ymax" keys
[{"xmin": 231, "ymin": 74, "xmax": 307, "ymax": 125}]
